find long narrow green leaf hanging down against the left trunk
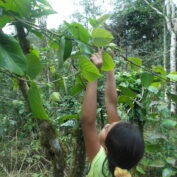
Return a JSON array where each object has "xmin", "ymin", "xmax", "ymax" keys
[{"xmin": 28, "ymin": 82, "xmax": 49, "ymax": 120}]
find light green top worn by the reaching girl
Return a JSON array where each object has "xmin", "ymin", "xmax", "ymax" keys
[{"xmin": 87, "ymin": 146, "xmax": 112, "ymax": 177}]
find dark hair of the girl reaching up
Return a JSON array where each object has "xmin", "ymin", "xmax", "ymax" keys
[{"xmin": 103, "ymin": 122, "xmax": 144, "ymax": 176}]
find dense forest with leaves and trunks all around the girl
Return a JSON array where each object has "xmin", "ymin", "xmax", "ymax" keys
[{"xmin": 0, "ymin": 0, "xmax": 177, "ymax": 177}]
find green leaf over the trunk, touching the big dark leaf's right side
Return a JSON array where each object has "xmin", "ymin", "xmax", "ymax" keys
[{"xmin": 26, "ymin": 54, "xmax": 42, "ymax": 79}]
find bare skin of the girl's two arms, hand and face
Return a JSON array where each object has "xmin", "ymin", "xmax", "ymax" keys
[{"xmin": 81, "ymin": 51, "xmax": 120, "ymax": 162}]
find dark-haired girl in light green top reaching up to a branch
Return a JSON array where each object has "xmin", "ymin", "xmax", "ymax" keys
[{"xmin": 81, "ymin": 52, "xmax": 144, "ymax": 177}]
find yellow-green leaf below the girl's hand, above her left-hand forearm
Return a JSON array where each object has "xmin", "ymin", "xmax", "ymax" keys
[{"xmin": 79, "ymin": 55, "xmax": 101, "ymax": 81}]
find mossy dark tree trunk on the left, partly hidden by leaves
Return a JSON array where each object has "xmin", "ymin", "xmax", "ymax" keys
[{"xmin": 16, "ymin": 23, "xmax": 65, "ymax": 177}]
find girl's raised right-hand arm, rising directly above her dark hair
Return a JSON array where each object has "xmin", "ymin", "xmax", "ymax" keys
[{"xmin": 105, "ymin": 70, "xmax": 120, "ymax": 123}]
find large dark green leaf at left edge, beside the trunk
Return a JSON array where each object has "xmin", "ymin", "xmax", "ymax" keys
[{"xmin": 0, "ymin": 33, "xmax": 27, "ymax": 75}]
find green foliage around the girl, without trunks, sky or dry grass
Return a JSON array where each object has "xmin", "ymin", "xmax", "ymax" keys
[{"xmin": 0, "ymin": 0, "xmax": 177, "ymax": 177}]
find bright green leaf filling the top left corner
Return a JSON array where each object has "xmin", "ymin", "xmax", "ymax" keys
[{"xmin": 0, "ymin": 0, "xmax": 31, "ymax": 16}]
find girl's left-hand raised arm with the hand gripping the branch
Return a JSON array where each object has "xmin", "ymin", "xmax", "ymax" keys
[{"xmin": 81, "ymin": 54, "xmax": 101, "ymax": 162}]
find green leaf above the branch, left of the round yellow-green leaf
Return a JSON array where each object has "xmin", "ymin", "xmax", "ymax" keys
[{"xmin": 67, "ymin": 22, "xmax": 90, "ymax": 43}]
